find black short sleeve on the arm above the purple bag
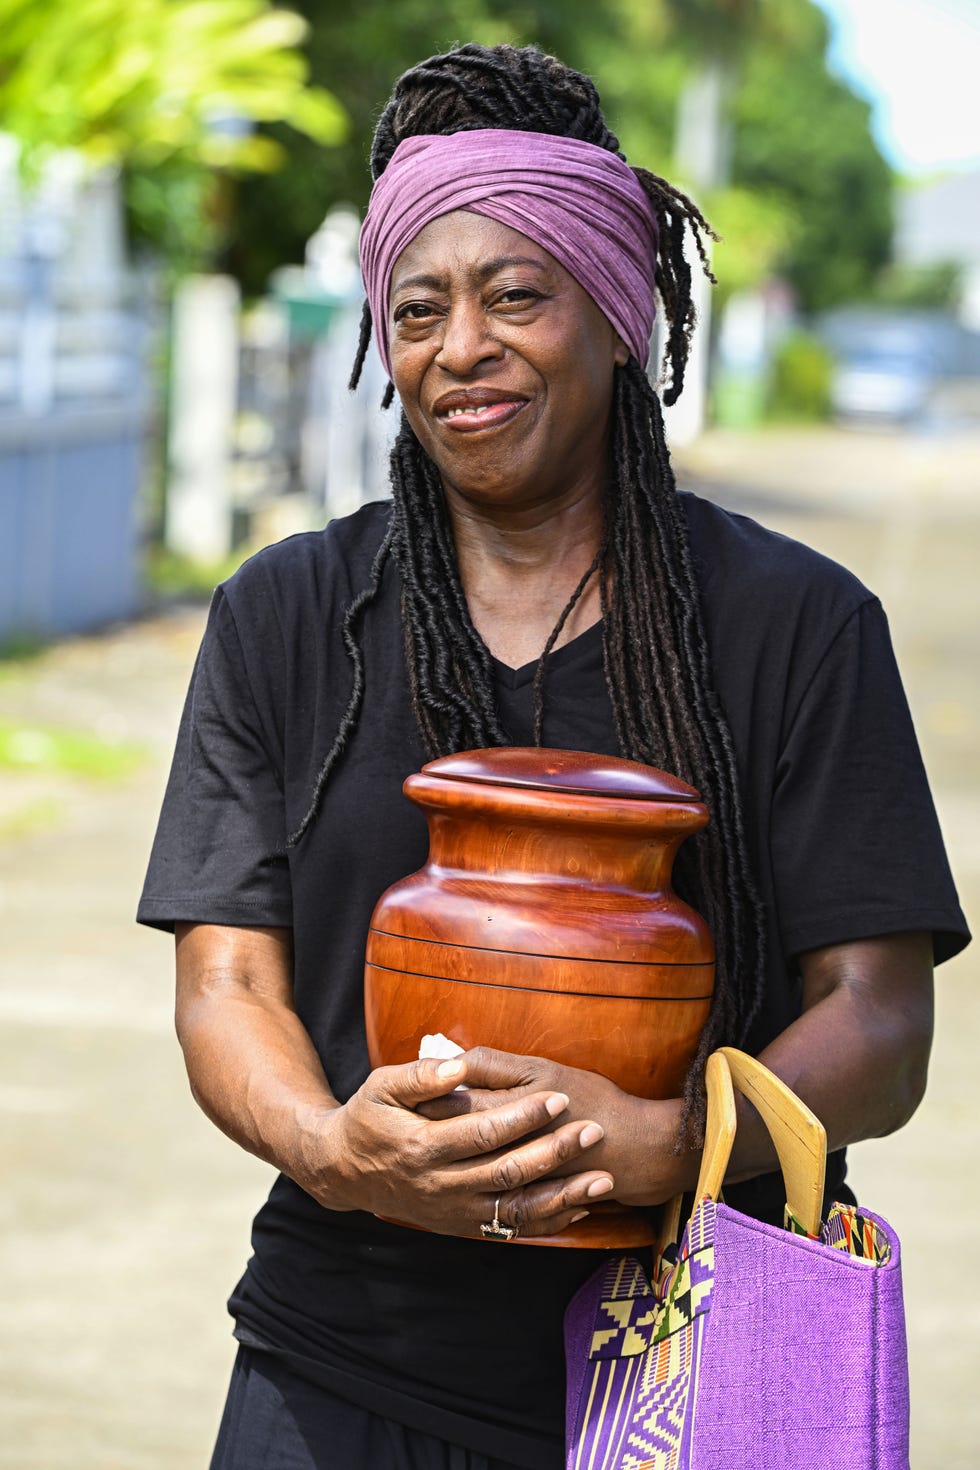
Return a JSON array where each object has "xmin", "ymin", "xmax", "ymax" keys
[{"xmin": 771, "ymin": 598, "xmax": 968, "ymax": 961}]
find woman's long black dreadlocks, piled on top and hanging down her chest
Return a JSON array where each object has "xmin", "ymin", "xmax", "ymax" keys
[{"xmin": 289, "ymin": 37, "xmax": 764, "ymax": 1136}]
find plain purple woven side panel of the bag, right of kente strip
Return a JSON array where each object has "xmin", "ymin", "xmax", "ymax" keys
[{"xmin": 695, "ymin": 1205, "xmax": 908, "ymax": 1470}]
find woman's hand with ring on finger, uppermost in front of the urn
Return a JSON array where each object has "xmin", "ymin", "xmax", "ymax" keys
[{"xmin": 302, "ymin": 1060, "xmax": 616, "ymax": 1236}]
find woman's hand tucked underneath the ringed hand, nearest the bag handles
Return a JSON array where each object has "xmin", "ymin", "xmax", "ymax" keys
[{"xmin": 419, "ymin": 1047, "xmax": 698, "ymax": 1205}]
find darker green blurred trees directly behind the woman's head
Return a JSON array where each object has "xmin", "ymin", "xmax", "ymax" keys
[{"xmin": 226, "ymin": 0, "xmax": 892, "ymax": 310}]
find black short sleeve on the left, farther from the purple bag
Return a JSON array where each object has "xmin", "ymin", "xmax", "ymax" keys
[{"xmin": 137, "ymin": 588, "xmax": 292, "ymax": 929}]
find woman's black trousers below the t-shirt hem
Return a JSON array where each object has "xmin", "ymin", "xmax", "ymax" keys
[{"xmin": 212, "ymin": 1347, "xmax": 537, "ymax": 1470}]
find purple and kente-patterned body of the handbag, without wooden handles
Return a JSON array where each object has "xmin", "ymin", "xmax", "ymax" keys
[{"xmin": 566, "ymin": 1200, "xmax": 908, "ymax": 1470}]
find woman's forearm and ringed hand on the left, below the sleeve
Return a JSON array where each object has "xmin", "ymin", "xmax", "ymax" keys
[{"xmin": 176, "ymin": 925, "xmax": 613, "ymax": 1235}]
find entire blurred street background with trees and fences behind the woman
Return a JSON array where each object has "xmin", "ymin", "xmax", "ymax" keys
[{"xmin": 0, "ymin": 0, "xmax": 980, "ymax": 1470}]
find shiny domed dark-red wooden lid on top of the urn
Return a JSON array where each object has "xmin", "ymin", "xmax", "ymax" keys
[{"xmin": 422, "ymin": 745, "xmax": 701, "ymax": 801}]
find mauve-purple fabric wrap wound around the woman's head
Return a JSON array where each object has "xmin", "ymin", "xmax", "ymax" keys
[{"xmin": 360, "ymin": 128, "xmax": 657, "ymax": 376}]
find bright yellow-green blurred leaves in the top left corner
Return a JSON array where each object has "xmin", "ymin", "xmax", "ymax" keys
[{"xmin": 0, "ymin": 0, "xmax": 344, "ymax": 176}]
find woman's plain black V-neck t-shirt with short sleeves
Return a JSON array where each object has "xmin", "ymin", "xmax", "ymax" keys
[{"xmin": 140, "ymin": 495, "xmax": 967, "ymax": 1470}]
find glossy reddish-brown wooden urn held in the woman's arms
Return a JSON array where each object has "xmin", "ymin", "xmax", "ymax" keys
[{"xmin": 364, "ymin": 747, "xmax": 714, "ymax": 1248}]
